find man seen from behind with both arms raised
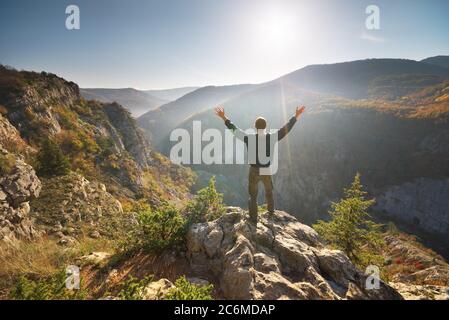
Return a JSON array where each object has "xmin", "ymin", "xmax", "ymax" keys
[{"xmin": 215, "ymin": 106, "xmax": 305, "ymax": 224}]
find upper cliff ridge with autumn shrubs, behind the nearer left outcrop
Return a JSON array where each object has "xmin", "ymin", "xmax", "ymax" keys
[{"xmin": 0, "ymin": 66, "xmax": 189, "ymax": 198}]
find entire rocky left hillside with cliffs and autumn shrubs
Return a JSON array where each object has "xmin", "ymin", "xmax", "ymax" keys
[{"xmin": 0, "ymin": 66, "xmax": 193, "ymax": 244}]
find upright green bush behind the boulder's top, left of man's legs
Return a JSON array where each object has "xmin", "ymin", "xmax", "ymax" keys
[{"xmin": 186, "ymin": 177, "xmax": 225, "ymax": 223}]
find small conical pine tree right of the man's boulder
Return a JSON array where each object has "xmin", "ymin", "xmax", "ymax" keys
[{"xmin": 313, "ymin": 173, "xmax": 383, "ymax": 268}]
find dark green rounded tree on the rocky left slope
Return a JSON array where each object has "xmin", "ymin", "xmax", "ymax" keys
[{"xmin": 36, "ymin": 139, "xmax": 70, "ymax": 177}]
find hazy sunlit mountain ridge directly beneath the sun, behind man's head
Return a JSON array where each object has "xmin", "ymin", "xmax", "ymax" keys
[{"xmin": 138, "ymin": 59, "xmax": 449, "ymax": 146}]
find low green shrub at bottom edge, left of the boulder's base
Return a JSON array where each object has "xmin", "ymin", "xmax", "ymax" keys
[{"xmin": 164, "ymin": 276, "xmax": 214, "ymax": 300}]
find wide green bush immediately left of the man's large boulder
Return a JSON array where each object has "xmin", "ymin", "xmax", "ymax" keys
[{"xmin": 122, "ymin": 205, "xmax": 187, "ymax": 252}]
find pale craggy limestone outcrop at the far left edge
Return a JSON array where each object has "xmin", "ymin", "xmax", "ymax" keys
[{"xmin": 0, "ymin": 147, "xmax": 42, "ymax": 242}]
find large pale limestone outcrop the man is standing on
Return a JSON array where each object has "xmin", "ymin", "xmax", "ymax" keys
[{"xmin": 187, "ymin": 207, "xmax": 402, "ymax": 299}]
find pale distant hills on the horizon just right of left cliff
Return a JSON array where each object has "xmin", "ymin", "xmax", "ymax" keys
[{"xmin": 80, "ymin": 88, "xmax": 168, "ymax": 117}]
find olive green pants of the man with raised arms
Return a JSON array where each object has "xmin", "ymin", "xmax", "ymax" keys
[{"xmin": 248, "ymin": 167, "xmax": 274, "ymax": 219}]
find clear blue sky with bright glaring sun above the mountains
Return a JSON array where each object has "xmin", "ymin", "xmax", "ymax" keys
[{"xmin": 0, "ymin": 0, "xmax": 449, "ymax": 89}]
